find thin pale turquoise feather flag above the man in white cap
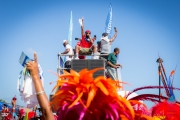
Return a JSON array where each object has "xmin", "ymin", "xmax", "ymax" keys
[{"xmin": 68, "ymin": 11, "xmax": 73, "ymax": 46}]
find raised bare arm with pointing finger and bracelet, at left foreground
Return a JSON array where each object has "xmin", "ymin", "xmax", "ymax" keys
[{"xmin": 27, "ymin": 53, "xmax": 54, "ymax": 120}]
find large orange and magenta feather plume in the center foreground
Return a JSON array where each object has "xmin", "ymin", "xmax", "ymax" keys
[{"xmin": 51, "ymin": 68, "xmax": 148, "ymax": 120}]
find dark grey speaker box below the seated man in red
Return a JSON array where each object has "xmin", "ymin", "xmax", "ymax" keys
[{"xmin": 71, "ymin": 59, "xmax": 105, "ymax": 78}]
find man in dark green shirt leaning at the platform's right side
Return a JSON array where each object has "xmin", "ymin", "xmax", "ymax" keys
[{"xmin": 107, "ymin": 48, "xmax": 122, "ymax": 80}]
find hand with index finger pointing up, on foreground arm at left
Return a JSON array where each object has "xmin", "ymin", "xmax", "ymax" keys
[{"xmin": 26, "ymin": 53, "xmax": 39, "ymax": 78}]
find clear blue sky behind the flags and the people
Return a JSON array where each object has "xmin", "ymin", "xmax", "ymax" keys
[{"xmin": 0, "ymin": 0, "xmax": 180, "ymax": 105}]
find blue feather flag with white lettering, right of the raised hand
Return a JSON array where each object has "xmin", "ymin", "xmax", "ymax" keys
[{"xmin": 105, "ymin": 4, "xmax": 112, "ymax": 38}]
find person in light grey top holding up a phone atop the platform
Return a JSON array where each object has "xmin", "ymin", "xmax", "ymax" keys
[{"xmin": 100, "ymin": 28, "xmax": 118, "ymax": 59}]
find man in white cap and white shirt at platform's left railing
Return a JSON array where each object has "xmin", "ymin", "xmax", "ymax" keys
[{"xmin": 61, "ymin": 40, "xmax": 74, "ymax": 72}]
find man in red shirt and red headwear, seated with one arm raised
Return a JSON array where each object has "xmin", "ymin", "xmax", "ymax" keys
[{"xmin": 75, "ymin": 18, "xmax": 96, "ymax": 59}]
